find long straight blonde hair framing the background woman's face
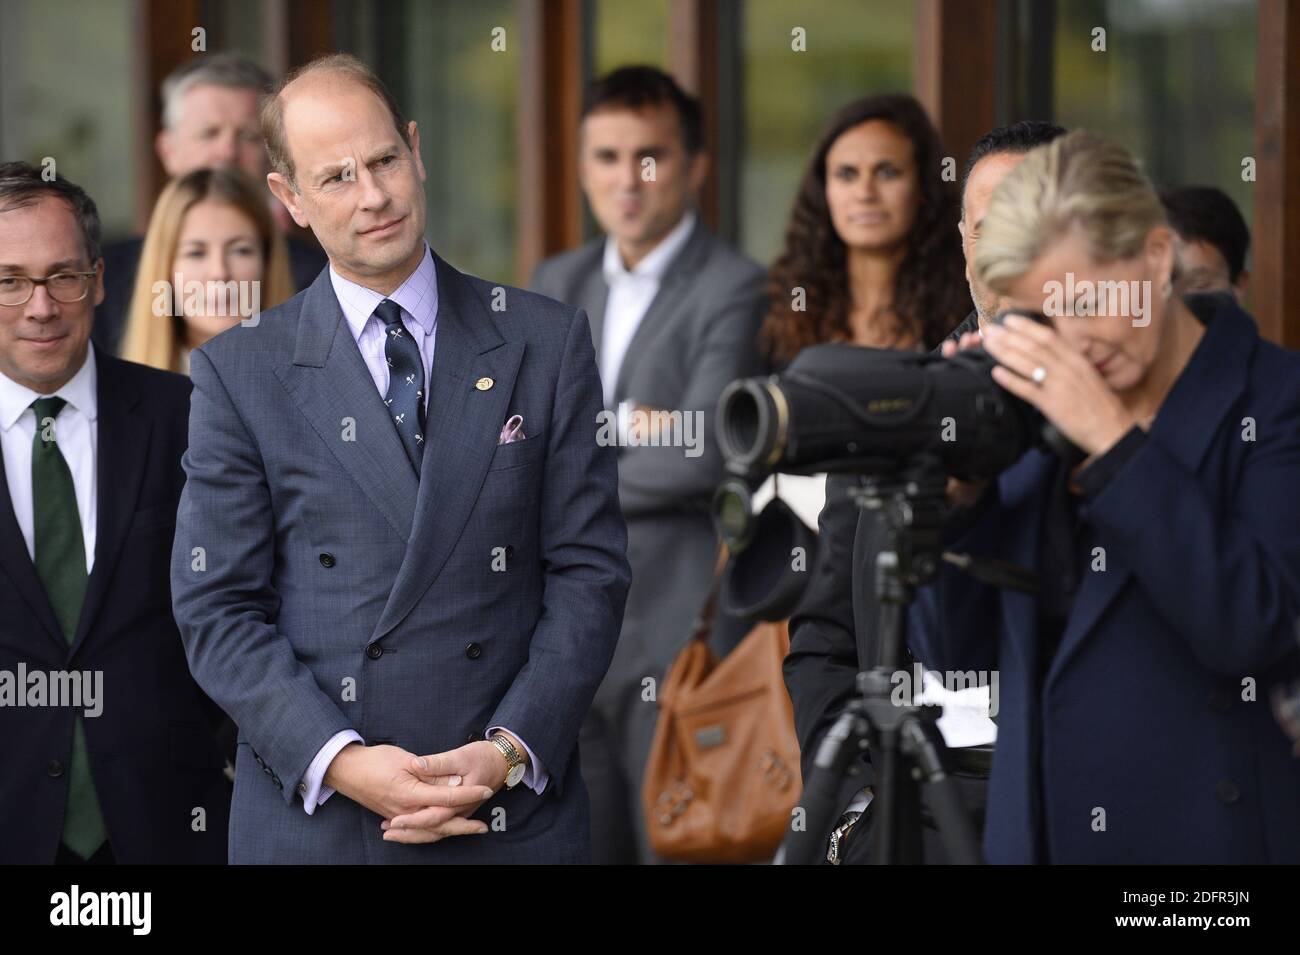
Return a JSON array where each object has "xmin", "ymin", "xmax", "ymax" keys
[{"xmin": 122, "ymin": 169, "xmax": 294, "ymax": 372}]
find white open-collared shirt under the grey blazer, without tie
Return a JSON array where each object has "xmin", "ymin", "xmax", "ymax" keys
[{"xmin": 601, "ymin": 209, "xmax": 696, "ymax": 408}]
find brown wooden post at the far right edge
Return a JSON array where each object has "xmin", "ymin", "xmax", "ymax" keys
[{"xmin": 1251, "ymin": 0, "xmax": 1300, "ymax": 348}]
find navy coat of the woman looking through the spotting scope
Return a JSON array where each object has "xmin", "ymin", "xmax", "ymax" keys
[{"xmin": 910, "ymin": 296, "xmax": 1300, "ymax": 864}]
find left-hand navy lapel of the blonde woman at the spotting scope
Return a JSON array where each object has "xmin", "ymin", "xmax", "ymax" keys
[{"xmin": 998, "ymin": 448, "xmax": 1056, "ymax": 673}]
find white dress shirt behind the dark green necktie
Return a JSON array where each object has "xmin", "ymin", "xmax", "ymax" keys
[{"xmin": 0, "ymin": 346, "xmax": 99, "ymax": 574}]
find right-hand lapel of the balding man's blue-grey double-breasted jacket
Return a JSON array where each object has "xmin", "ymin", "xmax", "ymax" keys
[{"xmin": 372, "ymin": 255, "xmax": 522, "ymax": 642}]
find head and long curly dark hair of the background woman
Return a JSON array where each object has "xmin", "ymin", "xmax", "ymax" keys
[{"xmin": 763, "ymin": 94, "xmax": 971, "ymax": 366}]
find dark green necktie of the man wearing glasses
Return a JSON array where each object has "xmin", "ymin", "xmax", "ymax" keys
[{"xmin": 31, "ymin": 398, "xmax": 108, "ymax": 859}]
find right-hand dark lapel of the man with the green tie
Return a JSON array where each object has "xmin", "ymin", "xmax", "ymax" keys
[{"xmin": 67, "ymin": 348, "xmax": 152, "ymax": 657}]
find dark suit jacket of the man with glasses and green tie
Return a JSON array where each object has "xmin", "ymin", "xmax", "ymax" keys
[{"xmin": 0, "ymin": 351, "xmax": 230, "ymax": 863}]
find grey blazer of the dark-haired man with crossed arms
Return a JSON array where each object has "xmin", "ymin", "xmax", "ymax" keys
[{"xmin": 532, "ymin": 223, "xmax": 766, "ymax": 707}]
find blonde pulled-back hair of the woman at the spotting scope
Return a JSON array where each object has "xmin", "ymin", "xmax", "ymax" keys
[{"xmin": 975, "ymin": 131, "xmax": 1166, "ymax": 294}]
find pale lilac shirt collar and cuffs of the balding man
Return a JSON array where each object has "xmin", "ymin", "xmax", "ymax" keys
[{"xmin": 299, "ymin": 246, "xmax": 550, "ymax": 815}]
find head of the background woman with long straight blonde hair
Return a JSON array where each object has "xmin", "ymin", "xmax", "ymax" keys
[{"xmin": 122, "ymin": 168, "xmax": 294, "ymax": 374}]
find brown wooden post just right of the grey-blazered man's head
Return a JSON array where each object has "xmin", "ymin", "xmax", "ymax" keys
[{"xmin": 668, "ymin": 0, "xmax": 722, "ymax": 233}]
